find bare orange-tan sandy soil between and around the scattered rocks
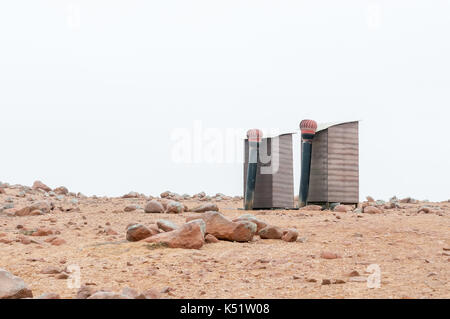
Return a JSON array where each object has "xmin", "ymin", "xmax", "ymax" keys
[{"xmin": 0, "ymin": 186, "xmax": 450, "ymax": 298}]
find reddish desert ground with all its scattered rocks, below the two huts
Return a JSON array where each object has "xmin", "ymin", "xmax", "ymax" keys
[{"xmin": 0, "ymin": 181, "xmax": 450, "ymax": 299}]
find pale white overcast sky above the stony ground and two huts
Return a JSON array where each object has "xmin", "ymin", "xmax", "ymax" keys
[{"xmin": 0, "ymin": 0, "xmax": 450, "ymax": 200}]
